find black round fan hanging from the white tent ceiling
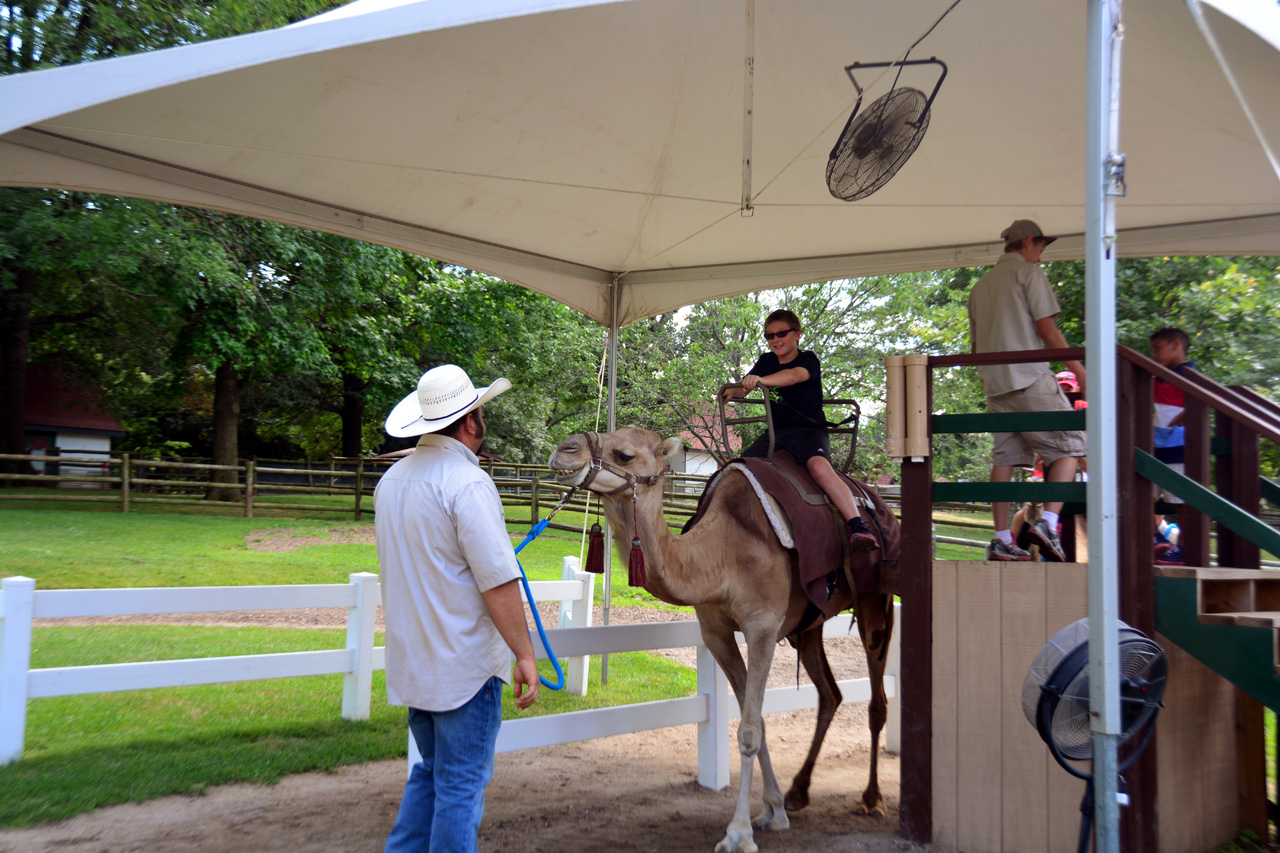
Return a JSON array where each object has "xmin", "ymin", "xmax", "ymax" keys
[{"xmin": 827, "ymin": 58, "xmax": 947, "ymax": 201}]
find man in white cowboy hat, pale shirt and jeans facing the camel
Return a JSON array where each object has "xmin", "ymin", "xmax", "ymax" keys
[{"xmin": 374, "ymin": 364, "xmax": 538, "ymax": 853}]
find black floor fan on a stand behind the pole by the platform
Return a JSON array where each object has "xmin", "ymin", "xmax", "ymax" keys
[{"xmin": 1023, "ymin": 619, "xmax": 1169, "ymax": 853}]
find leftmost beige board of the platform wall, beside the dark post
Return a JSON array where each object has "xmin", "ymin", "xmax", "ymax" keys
[{"xmin": 932, "ymin": 561, "xmax": 968, "ymax": 850}]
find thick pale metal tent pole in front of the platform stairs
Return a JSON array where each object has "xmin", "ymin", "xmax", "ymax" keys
[{"xmin": 1084, "ymin": 0, "xmax": 1121, "ymax": 853}]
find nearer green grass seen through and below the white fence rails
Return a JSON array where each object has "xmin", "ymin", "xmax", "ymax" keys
[{"xmin": 0, "ymin": 625, "xmax": 696, "ymax": 827}]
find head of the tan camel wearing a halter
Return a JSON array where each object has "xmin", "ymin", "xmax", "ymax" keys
[{"xmin": 547, "ymin": 427, "xmax": 680, "ymax": 494}]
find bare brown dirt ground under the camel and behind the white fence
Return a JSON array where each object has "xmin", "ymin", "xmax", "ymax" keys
[{"xmin": 0, "ymin": 532, "xmax": 937, "ymax": 853}]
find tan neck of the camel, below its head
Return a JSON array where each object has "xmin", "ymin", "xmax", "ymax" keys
[{"xmin": 604, "ymin": 487, "xmax": 721, "ymax": 605}]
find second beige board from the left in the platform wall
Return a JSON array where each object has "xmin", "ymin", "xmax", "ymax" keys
[{"xmin": 955, "ymin": 562, "xmax": 1005, "ymax": 850}]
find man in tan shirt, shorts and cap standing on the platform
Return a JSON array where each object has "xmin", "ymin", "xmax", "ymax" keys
[{"xmin": 969, "ymin": 219, "xmax": 1085, "ymax": 562}]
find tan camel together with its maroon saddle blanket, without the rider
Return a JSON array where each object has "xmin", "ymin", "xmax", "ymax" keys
[{"xmin": 548, "ymin": 384, "xmax": 901, "ymax": 853}]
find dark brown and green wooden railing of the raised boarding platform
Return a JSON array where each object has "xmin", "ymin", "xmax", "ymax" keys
[{"xmin": 901, "ymin": 347, "xmax": 1280, "ymax": 839}]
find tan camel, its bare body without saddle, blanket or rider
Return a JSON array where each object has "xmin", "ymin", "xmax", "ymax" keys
[{"xmin": 548, "ymin": 427, "xmax": 893, "ymax": 853}]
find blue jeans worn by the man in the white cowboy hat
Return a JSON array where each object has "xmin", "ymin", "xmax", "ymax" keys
[{"xmin": 385, "ymin": 678, "xmax": 502, "ymax": 853}]
